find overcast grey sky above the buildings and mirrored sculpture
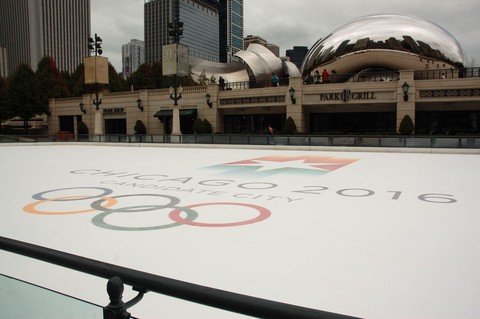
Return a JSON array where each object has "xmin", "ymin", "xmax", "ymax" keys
[{"xmin": 91, "ymin": 0, "xmax": 480, "ymax": 72}]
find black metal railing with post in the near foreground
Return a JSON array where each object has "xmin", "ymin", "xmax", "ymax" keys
[{"xmin": 0, "ymin": 237, "xmax": 356, "ymax": 319}]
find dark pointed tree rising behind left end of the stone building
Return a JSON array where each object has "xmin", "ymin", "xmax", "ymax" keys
[{"xmin": 35, "ymin": 57, "xmax": 69, "ymax": 113}]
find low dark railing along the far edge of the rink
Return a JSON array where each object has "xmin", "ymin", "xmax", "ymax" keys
[{"xmin": 0, "ymin": 134, "xmax": 480, "ymax": 149}]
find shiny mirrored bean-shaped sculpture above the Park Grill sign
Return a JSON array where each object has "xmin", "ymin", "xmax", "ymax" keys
[{"xmin": 301, "ymin": 14, "xmax": 465, "ymax": 75}]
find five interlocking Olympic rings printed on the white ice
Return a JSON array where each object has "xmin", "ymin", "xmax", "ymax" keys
[{"xmin": 23, "ymin": 187, "xmax": 271, "ymax": 231}]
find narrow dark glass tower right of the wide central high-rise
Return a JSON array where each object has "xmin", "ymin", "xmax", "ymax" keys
[{"xmin": 219, "ymin": 0, "xmax": 243, "ymax": 63}]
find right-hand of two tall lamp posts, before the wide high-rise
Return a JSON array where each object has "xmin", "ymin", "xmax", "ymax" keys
[{"xmin": 168, "ymin": 20, "xmax": 183, "ymax": 135}]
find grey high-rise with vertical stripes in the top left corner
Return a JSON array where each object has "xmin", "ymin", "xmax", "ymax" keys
[{"xmin": 0, "ymin": 0, "xmax": 90, "ymax": 73}]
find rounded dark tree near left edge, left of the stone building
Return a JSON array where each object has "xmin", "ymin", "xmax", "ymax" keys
[{"xmin": 8, "ymin": 64, "xmax": 40, "ymax": 130}]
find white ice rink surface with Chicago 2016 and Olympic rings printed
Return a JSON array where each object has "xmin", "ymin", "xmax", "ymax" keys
[{"xmin": 0, "ymin": 145, "xmax": 480, "ymax": 319}]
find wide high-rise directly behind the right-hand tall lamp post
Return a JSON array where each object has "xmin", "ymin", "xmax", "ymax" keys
[{"xmin": 144, "ymin": 0, "xmax": 219, "ymax": 64}]
